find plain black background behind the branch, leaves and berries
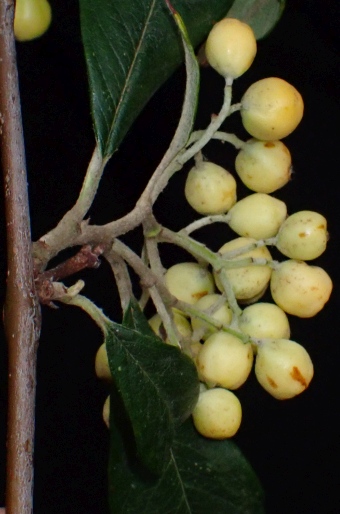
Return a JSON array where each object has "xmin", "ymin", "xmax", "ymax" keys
[{"xmin": 0, "ymin": 0, "xmax": 340, "ymax": 514}]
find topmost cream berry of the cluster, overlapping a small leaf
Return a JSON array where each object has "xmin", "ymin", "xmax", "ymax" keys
[{"xmin": 205, "ymin": 18, "xmax": 257, "ymax": 79}]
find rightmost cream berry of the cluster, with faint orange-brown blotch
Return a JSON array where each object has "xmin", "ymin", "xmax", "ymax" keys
[{"xmin": 270, "ymin": 259, "xmax": 333, "ymax": 318}]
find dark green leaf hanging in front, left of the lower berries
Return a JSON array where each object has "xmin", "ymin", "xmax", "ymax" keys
[{"xmin": 105, "ymin": 305, "xmax": 199, "ymax": 473}]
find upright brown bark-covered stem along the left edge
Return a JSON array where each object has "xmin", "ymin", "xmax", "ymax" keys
[{"xmin": 0, "ymin": 0, "xmax": 40, "ymax": 514}]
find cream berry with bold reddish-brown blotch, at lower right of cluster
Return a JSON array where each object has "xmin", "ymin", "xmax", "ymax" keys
[{"xmin": 255, "ymin": 339, "xmax": 314, "ymax": 400}]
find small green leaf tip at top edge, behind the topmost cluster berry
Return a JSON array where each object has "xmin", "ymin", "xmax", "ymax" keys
[{"xmin": 228, "ymin": 0, "xmax": 286, "ymax": 39}]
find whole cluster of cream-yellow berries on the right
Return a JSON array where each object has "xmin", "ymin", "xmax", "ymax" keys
[{"xmin": 96, "ymin": 18, "xmax": 332, "ymax": 439}]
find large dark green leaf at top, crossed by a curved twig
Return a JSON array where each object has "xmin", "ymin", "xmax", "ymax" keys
[{"xmin": 80, "ymin": 0, "xmax": 233, "ymax": 156}]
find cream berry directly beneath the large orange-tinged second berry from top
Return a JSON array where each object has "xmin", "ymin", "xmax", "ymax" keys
[{"xmin": 235, "ymin": 138, "xmax": 292, "ymax": 193}]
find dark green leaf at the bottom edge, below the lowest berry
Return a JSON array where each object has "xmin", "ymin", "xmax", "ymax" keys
[{"xmin": 109, "ymin": 416, "xmax": 264, "ymax": 514}]
